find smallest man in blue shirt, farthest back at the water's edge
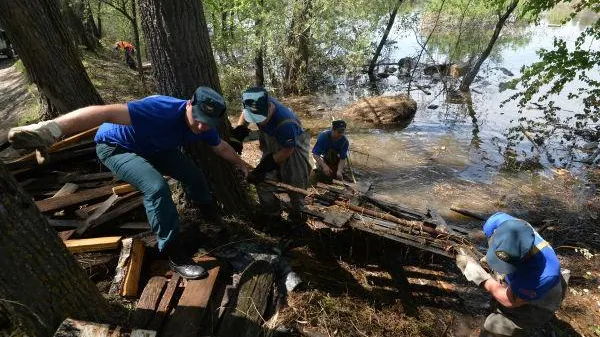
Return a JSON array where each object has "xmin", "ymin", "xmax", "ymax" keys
[{"xmin": 312, "ymin": 120, "xmax": 350, "ymax": 184}]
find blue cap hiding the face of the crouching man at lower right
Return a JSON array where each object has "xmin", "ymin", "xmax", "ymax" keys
[{"xmin": 485, "ymin": 218, "xmax": 535, "ymax": 274}]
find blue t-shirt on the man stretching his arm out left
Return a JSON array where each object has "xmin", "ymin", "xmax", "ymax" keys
[{"xmin": 94, "ymin": 95, "xmax": 221, "ymax": 155}]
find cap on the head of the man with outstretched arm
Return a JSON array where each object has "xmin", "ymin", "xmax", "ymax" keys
[{"xmin": 191, "ymin": 87, "xmax": 227, "ymax": 127}]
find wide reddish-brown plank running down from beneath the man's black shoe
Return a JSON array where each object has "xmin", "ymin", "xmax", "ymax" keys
[{"xmin": 161, "ymin": 266, "xmax": 220, "ymax": 337}]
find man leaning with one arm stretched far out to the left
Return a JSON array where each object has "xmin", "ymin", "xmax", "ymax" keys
[{"xmin": 8, "ymin": 87, "xmax": 248, "ymax": 279}]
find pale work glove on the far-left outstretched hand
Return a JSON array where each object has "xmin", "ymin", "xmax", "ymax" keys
[{"xmin": 8, "ymin": 120, "xmax": 62, "ymax": 164}]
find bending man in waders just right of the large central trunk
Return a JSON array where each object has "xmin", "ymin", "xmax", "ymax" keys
[{"xmin": 232, "ymin": 87, "xmax": 310, "ymax": 220}]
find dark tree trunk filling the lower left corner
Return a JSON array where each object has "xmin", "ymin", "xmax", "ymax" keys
[{"xmin": 0, "ymin": 163, "xmax": 109, "ymax": 336}]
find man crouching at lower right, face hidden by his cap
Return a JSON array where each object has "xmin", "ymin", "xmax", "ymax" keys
[{"xmin": 456, "ymin": 212, "xmax": 567, "ymax": 336}]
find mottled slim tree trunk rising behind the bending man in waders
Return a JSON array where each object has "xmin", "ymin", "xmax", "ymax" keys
[{"xmin": 283, "ymin": 0, "xmax": 312, "ymax": 94}]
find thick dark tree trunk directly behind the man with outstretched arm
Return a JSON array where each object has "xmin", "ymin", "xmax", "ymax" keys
[{"xmin": 139, "ymin": 0, "xmax": 248, "ymax": 213}]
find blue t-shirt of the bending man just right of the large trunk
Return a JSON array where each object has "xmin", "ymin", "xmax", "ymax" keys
[{"xmin": 258, "ymin": 97, "xmax": 304, "ymax": 148}]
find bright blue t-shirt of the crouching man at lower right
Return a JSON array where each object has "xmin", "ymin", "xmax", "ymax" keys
[{"xmin": 483, "ymin": 212, "xmax": 561, "ymax": 301}]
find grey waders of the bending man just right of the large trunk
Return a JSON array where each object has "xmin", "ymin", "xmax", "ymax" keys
[{"xmin": 256, "ymin": 131, "xmax": 311, "ymax": 216}]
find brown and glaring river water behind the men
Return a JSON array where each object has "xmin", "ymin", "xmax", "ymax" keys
[{"xmin": 300, "ymin": 11, "xmax": 593, "ymax": 220}]
